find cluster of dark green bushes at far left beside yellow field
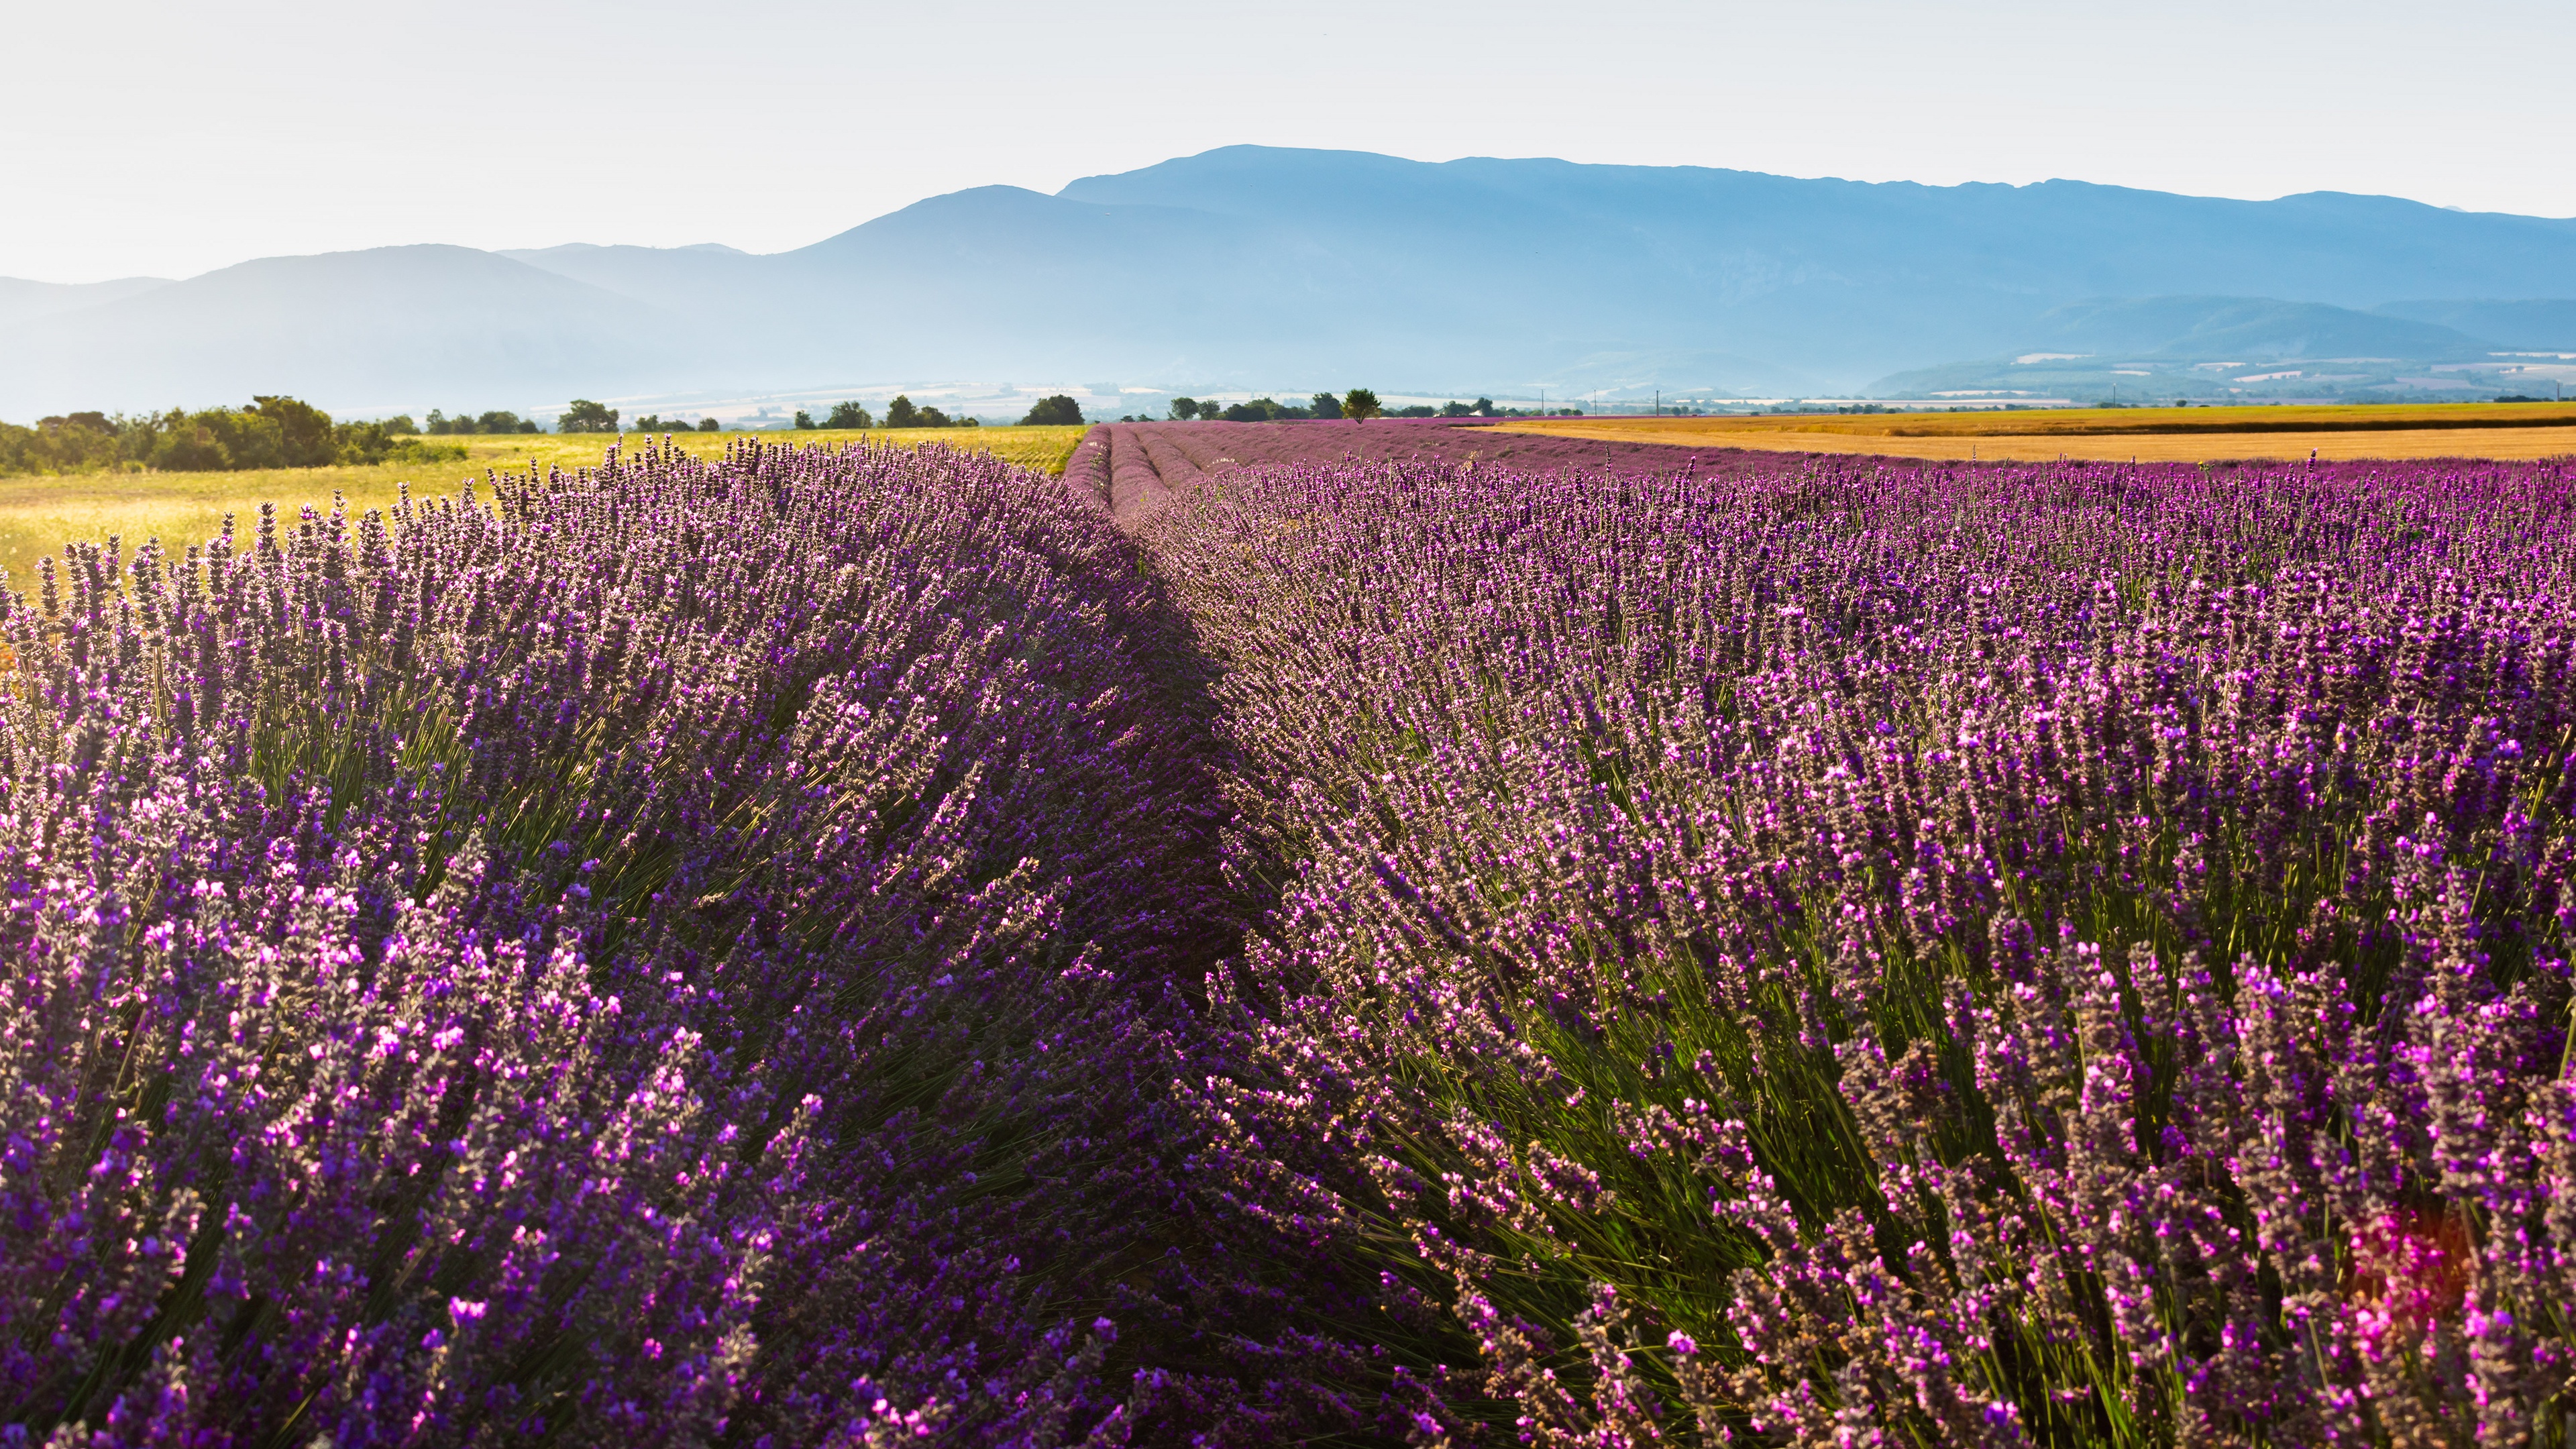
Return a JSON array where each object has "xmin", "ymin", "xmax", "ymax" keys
[{"xmin": 0, "ymin": 397, "xmax": 466, "ymax": 474}]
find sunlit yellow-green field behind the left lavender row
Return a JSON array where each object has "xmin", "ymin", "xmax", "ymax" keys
[{"xmin": 0, "ymin": 428, "xmax": 1082, "ymax": 593}]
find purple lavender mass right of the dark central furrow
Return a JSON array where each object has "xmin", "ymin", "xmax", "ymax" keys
[{"xmin": 1149, "ymin": 462, "xmax": 2576, "ymax": 1446}]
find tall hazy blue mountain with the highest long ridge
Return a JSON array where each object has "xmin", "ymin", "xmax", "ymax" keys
[{"xmin": 458, "ymin": 147, "xmax": 2576, "ymax": 392}]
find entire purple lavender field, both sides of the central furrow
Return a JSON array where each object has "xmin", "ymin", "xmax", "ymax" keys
[{"xmin": 0, "ymin": 425, "xmax": 2576, "ymax": 1449}]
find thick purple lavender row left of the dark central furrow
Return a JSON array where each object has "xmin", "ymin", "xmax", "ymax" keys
[{"xmin": 0, "ymin": 443, "xmax": 1260, "ymax": 1449}]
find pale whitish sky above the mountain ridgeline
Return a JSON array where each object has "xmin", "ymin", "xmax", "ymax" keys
[{"xmin": 0, "ymin": 0, "xmax": 2576, "ymax": 281}]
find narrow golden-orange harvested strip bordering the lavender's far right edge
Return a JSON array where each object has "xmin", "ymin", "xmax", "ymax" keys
[{"xmin": 1489, "ymin": 413, "xmax": 2576, "ymax": 462}]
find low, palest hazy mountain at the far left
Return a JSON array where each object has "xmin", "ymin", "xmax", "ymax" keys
[{"xmin": 0, "ymin": 245, "xmax": 690, "ymax": 418}]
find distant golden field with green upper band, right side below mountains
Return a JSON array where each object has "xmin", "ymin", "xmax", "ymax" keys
[{"xmin": 1499, "ymin": 402, "xmax": 2576, "ymax": 462}]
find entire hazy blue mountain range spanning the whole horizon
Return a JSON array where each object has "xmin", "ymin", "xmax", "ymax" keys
[{"xmin": 0, "ymin": 147, "xmax": 2576, "ymax": 418}]
